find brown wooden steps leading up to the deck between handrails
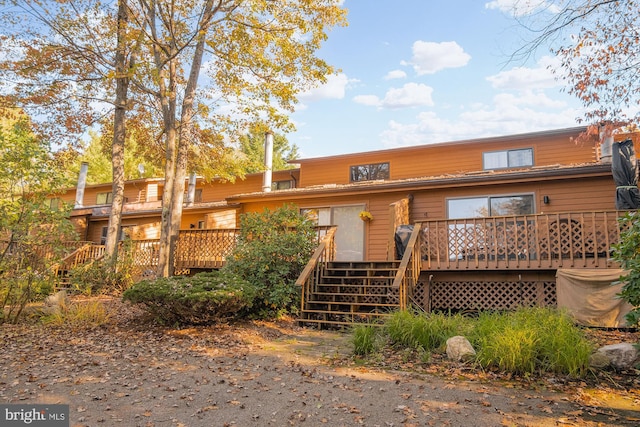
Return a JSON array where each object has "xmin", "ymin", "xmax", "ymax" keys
[{"xmin": 299, "ymin": 261, "xmax": 400, "ymax": 326}]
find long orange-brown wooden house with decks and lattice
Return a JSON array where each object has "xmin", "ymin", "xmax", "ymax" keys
[{"xmin": 51, "ymin": 127, "xmax": 640, "ymax": 328}]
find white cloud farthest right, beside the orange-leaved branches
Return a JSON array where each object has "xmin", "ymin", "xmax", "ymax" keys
[{"xmin": 487, "ymin": 56, "xmax": 559, "ymax": 90}]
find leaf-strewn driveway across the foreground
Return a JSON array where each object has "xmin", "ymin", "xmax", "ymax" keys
[{"xmin": 0, "ymin": 300, "xmax": 640, "ymax": 427}]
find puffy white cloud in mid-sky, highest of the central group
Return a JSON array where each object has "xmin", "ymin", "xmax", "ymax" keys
[{"xmin": 403, "ymin": 40, "xmax": 471, "ymax": 75}]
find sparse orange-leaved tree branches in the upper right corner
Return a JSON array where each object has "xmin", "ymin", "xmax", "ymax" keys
[{"xmin": 514, "ymin": 0, "xmax": 640, "ymax": 124}]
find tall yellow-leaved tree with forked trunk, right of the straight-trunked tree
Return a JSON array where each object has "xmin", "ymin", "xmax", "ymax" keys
[{"xmin": 125, "ymin": 0, "xmax": 345, "ymax": 276}]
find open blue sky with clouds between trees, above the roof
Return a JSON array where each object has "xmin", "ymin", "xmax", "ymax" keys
[{"xmin": 287, "ymin": 0, "xmax": 581, "ymax": 158}]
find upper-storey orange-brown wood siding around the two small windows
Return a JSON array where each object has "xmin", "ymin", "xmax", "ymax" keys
[{"xmin": 300, "ymin": 133, "xmax": 597, "ymax": 187}]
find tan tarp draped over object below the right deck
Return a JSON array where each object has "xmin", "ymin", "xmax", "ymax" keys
[{"xmin": 556, "ymin": 269, "xmax": 632, "ymax": 328}]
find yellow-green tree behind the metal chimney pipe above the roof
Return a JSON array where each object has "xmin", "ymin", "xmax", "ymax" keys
[{"xmin": 239, "ymin": 124, "xmax": 299, "ymax": 173}]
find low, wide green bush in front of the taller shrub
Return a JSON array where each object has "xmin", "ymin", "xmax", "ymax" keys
[{"xmin": 122, "ymin": 271, "xmax": 256, "ymax": 325}]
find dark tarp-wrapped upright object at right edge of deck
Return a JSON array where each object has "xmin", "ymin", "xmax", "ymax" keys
[{"xmin": 611, "ymin": 139, "xmax": 640, "ymax": 209}]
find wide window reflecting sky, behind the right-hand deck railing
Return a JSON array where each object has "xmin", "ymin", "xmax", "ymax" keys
[{"xmin": 447, "ymin": 194, "xmax": 534, "ymax": 219}]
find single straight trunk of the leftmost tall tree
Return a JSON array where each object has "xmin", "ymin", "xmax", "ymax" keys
[{"xmin": 105, "ymin": 0, "xmax": 129, "ymax": 263}]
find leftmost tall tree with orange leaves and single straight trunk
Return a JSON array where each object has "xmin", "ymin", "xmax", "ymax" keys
[{"xmin": 0, "ymin": 0, "xmax": 140, "ymax": 261}]
